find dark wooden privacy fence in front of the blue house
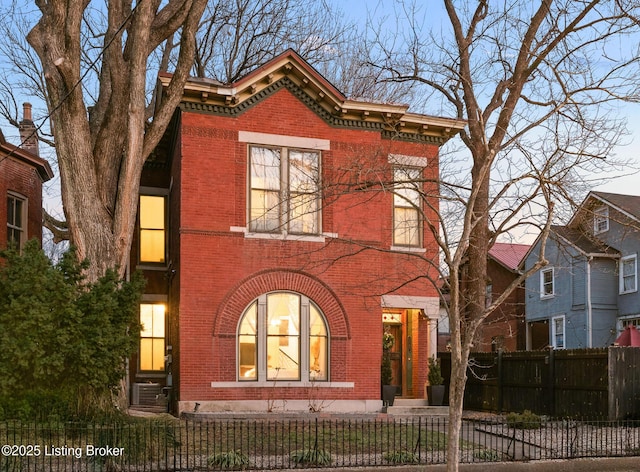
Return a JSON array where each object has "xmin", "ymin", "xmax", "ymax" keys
[{"xmin": 438, "ymin": 347, "xmax": 640, "ymax": 420}]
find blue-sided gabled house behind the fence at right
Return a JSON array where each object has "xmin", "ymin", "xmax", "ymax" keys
[{"xmin": 523, "ymin": 192, "xmax": 640, "ymax": 349}]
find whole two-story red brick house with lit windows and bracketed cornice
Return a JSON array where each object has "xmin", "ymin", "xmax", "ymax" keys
[{"xmin": 131, "ymin": 51, "xmax": 464, "ymax": 412}]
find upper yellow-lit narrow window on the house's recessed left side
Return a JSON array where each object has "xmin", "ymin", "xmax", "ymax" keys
[{"xmin": 139, "ymin": 195, "xmax": 167, "ymax": 264}]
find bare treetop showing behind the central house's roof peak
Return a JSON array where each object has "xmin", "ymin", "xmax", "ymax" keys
[{"xmin": 194, "ymin": 0, "xmax": 352, "ymax": 83}]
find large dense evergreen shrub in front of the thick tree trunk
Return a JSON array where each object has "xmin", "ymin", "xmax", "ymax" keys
[{"xmin": 0, "ymin": 240, "xmax": 144, "ymax": 419}]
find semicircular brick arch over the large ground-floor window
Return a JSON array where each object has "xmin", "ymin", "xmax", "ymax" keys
[{"xmin": 213, "ymin": 270, "xmax": 351, "ymax": 342}]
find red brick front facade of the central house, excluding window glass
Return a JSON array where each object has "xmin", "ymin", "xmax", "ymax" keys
[{"xmin": 133, "ymin": 52, "xmax": 461, "ymax": 411}]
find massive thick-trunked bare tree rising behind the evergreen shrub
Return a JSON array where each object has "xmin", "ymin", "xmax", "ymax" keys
[{"xmin": 3, "ymin": 0, "xmax": 206, "ymax": 279}]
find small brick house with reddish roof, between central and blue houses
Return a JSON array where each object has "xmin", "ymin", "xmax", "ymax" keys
[{"xmin": 473, "ymin": 243, "xmax": 531, "ymax": 352}]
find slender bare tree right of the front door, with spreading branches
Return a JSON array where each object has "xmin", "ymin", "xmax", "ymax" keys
[{"xmin": 356, "ymin": 0, "xmax": 640, "ymax": 470}]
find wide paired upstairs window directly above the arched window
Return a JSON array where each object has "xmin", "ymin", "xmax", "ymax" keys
[{"xmin": 249, "ymin": 146, "xmax": 320, "ymax": 234}]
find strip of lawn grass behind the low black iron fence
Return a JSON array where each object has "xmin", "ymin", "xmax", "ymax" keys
[{"xmin": 0, "ymin": 417, "xmax": 446, "ymax": 462}]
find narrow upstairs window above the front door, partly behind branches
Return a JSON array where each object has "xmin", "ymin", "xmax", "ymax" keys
[{"xmin": 393, "ymin": 167, "xmax": 422, "ymax": 247}]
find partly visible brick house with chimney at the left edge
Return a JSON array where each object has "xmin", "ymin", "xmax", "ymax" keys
[{"xmin": 0, "ymin": 104, "xmax": 53, "ymax": 249}]
